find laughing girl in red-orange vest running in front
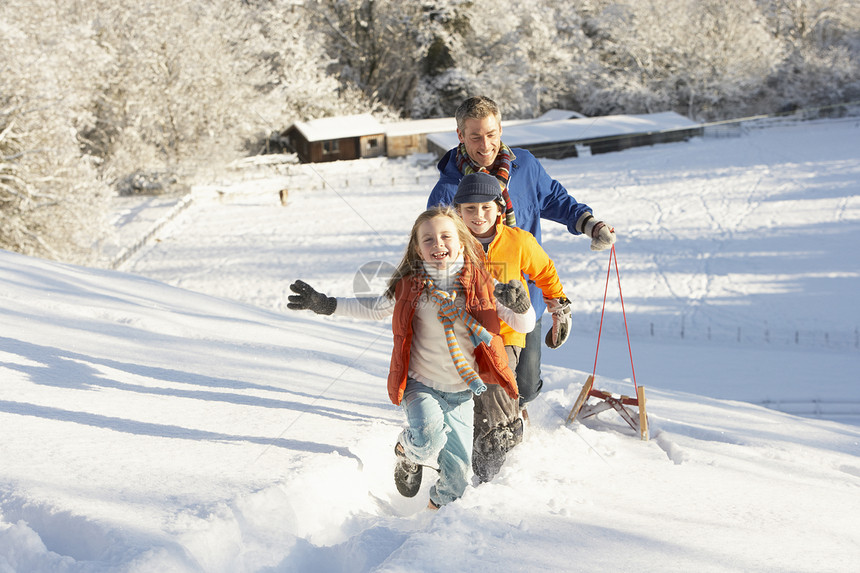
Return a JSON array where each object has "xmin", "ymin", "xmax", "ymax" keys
[{"xmin": 287, "ymin": 207, "xmax": 535, "ymax": 509}]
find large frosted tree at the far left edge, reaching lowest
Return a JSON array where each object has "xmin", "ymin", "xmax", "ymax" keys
[{"xmin": 0, "ymin": 0, "xmax": 108, "ymax": 262}]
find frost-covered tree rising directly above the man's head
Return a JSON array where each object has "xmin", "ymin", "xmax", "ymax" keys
[{"xmin": 412, "ymin": 0, "xmax": 589, "ymax": 118}]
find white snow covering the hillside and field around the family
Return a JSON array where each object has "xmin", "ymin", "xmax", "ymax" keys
[{"xmin": 0, "ymin": 120, "xmax": 860, "ymax": 573}]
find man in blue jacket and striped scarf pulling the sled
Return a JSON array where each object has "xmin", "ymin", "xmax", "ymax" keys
[{"xmin": 427, "ymin": 96, "xmax": 615, "ymax": 407}]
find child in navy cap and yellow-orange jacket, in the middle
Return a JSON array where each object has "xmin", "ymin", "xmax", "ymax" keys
[{"xmin": 452, "ymin": 173, "xmax": 570, "ymax": 481}]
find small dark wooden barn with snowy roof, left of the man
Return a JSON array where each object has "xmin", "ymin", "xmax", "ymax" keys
[{"xmin": 284, "ymin": 113, "xmax": 385, "ymax": 163}]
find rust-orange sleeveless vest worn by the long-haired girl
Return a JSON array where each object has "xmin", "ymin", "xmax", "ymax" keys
[{"xmin": 388, "ymin": 261, "xmax": 519, "ymax": 405}]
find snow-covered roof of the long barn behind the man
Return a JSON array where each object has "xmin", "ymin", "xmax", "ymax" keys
[{"xmin": 427, "ymin": 111, "xmax": 698, "ymax": 149}]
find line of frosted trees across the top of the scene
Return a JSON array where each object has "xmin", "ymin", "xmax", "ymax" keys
[{"xmin": 0, "ymin": 0, "xmax": 860, "ymax": 263}]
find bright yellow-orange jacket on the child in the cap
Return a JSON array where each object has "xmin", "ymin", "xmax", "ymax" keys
[{"xmin": 487, "ymin": 217, "xmax": 564, "ymax": 347}]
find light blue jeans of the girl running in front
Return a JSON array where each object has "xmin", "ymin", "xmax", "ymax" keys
[{"xmin": 400, "ymin": 378, "xmax": 472, "ymax": 505}]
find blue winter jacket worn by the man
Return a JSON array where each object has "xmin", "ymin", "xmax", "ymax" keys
[{"xmin": 427, "ymin": 147, "xmax": 591, "ymax": 318}]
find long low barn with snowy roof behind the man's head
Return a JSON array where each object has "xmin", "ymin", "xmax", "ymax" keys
[{"xmin": 427, "ymin": 111, "xmax": 703, "ymax": 159}]
